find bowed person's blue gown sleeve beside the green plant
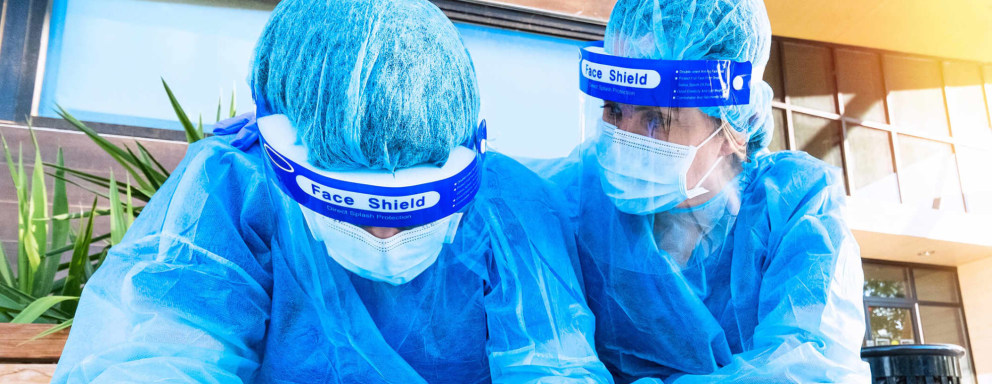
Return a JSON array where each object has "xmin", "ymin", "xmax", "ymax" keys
[{"xmin": 52, "ymin": 136, "xmax": 272, "ymax": 383}]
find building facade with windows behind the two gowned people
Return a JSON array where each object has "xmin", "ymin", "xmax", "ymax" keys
[{"xmin": 0, "ymin": 0, "xmax": 992, "ymax": 383}]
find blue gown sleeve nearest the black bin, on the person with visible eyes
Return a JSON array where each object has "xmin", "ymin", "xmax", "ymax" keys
[{"xmin": 666, "ymin": 155, "xmax": 869, "ymax": 384}]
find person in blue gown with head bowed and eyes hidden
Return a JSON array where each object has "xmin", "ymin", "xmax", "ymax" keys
[{"xmin": 53, "ymin": 0, "xmax": 612, "ymax": 384}]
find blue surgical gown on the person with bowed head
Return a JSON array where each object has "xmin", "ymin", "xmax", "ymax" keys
[{"xmin": 53, "ymin": 121, "xmax": 611, "ymax": 384}]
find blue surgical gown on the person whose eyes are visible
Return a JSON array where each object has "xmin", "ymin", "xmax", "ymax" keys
[{"xmin": 533, "ymin": 145, "xmax": 869, "ymax": 383}]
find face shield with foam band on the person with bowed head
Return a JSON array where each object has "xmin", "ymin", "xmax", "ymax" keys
[{"xmin": 257, "ymin": 115, "xmax": 486, "ymax": 285}]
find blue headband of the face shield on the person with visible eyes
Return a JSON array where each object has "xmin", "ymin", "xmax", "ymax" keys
[{"xmin": 579, "ymin": 41, "xmax": 751, "ymax": 108}]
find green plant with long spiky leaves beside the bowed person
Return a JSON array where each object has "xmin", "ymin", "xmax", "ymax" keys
[{"xmin": 0, "ymin": 80, "xmax": 236, "ymax": 328}]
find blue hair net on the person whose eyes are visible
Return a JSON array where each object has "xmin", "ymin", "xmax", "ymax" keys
[{"xmin": 604, "ymin": 0, "xmax": 773, "ymax": 156}]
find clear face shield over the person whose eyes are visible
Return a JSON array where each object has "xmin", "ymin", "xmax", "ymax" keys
[{"xmin": 579, "ymin": 42, "xmax": 761, "ymax": 215}]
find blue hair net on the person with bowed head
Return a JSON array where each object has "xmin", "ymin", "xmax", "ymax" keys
[{"xmin": 251, "ymin": 0, "xmax": 479, "ymax": 170}]
